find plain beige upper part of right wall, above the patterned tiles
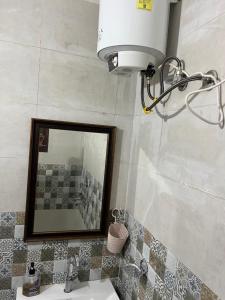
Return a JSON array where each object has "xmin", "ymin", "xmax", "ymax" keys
[{"xmin": 127, "ymin": 0, "xmax": 225, "ymax": 299}]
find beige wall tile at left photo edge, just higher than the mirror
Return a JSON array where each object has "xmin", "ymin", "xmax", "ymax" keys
[{"xmin": 0, "ymin": 42, "xmax": 40, "ymax": 104}]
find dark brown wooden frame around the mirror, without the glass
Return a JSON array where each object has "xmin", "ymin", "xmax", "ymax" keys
[{"xmin": 24, "ymin": 119, "xmax": 116, "ymax": 242}]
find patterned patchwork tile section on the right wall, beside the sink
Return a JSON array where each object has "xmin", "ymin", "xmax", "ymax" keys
[{"xmin": 116, "ymin": 213, "xmax": 218, "ymax": 300}]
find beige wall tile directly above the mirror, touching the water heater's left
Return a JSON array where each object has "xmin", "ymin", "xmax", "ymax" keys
[{"xmin": 38, "ymin": 50, "xmax": 117, "ymax": 113}]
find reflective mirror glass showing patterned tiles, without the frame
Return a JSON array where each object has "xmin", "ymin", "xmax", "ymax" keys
[{"xmin": 33, "ymin": 127, "xmax": 108, "ymax": 233}]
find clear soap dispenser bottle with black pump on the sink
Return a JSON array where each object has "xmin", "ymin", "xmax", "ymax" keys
[{"xmin": 23, "ymin": 262, "xmax": 40, "ymax": 297}]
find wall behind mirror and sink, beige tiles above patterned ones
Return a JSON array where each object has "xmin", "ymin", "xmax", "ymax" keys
[{"xmin": 0, "ymin": 0, "xmax": 136, "ymax": 300}]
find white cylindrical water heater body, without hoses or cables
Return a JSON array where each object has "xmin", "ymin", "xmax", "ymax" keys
[{"xmin": 97, "ymin": 0, "xmax": 174, "ymax": 73}]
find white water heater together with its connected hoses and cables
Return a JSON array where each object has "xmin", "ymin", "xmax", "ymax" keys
[{"xmin": 97, "ymin": 0, "xmax": 225, "ymax": 128}]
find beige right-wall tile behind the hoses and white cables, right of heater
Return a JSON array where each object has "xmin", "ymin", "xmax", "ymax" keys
[{"xmin": 166, "ymin": 12, "xmax": 225, "ymax": 111}]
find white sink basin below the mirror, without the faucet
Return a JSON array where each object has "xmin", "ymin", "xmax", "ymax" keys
[{"xmin": 16, "ymin": 279, "xmax": 119, "ymax": 300}]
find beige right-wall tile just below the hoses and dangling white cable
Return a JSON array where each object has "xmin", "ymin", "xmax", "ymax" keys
[{"xmin": 159, "ymin": 106, "xmax": 225, "ymax": 199}]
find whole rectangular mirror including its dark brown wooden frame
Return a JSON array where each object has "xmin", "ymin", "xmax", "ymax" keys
[{"xmin": 24, "ymin": 119, "xmax": 115, "ymax": 241}]
